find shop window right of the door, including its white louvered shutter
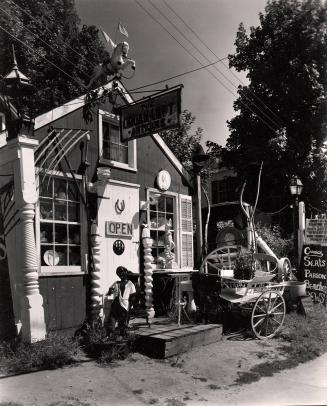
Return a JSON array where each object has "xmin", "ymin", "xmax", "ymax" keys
[{"xmin": 148, "ymin": 191, "xmax": 193, "ymax": 268}]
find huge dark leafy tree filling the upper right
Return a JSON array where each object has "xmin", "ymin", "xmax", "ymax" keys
[{"xmin": 208, "ymin": 0, "xmax": 327, "ymax": 214}]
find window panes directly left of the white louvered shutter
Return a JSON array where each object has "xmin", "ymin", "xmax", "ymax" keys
[{"xmin": 149, "ymin": 192, "xmax": 176, "ymax": 264}]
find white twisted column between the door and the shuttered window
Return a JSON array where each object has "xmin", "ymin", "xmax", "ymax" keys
[{"xmin": 142, "ymin": 224, "xmax": 155, "ymax": 320}]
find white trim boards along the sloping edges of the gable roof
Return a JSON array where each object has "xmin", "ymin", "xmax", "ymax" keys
[{"xmin": 34, "ymin": 80, "xmax": 192, "ymax": 186}]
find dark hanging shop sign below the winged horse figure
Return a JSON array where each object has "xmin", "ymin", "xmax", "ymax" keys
[{"xmin": 120, "ymin": 85, "xmax": 182, "ymax": 141}]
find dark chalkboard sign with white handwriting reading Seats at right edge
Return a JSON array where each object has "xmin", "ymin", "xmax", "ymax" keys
[{"xmin": 302, "ymin": 244, "xmax": 327, "ymax": 304}]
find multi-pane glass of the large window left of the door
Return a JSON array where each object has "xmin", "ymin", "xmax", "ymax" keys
[{"xmin": 39, "ymin": 177, "xmax": 81, "ymax": 267}]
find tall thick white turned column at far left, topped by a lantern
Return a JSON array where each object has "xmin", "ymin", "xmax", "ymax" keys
[{"xmin": 13, "ymin": 136, "xmax": 46, "ymax": 342}]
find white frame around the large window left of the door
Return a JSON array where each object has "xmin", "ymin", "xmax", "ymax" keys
[{"xmin": 35, "ymin": 170, "xmax": 87, "ymax": 276}]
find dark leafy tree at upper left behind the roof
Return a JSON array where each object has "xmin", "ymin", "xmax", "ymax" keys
[{"xmin": 0, "ymin": 0, "xmax": 106, "ymax": 115}]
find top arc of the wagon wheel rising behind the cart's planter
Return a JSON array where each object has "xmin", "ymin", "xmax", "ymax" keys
[{"xmin": 200, "ymin": 245, "xmax": 241, "ymax": 275}]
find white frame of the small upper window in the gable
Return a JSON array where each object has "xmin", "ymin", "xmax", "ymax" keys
[{"xmin": 98, "ymin": 109, "xmax": 137, "ymax": 172}]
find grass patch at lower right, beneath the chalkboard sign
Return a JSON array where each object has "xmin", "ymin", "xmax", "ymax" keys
[{"xmin": 235, "ymin": 305, "xmax": 327, "ymax": 385}]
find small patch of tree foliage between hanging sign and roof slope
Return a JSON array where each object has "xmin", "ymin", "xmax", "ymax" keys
[{"xmin": 160, "ymin": 110, "xmax": 203, "ymax": 170}]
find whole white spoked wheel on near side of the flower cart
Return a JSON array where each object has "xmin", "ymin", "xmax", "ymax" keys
[{"xmin": 251, "ymin": 290, "xmax": 286, "ymax": 340}]
